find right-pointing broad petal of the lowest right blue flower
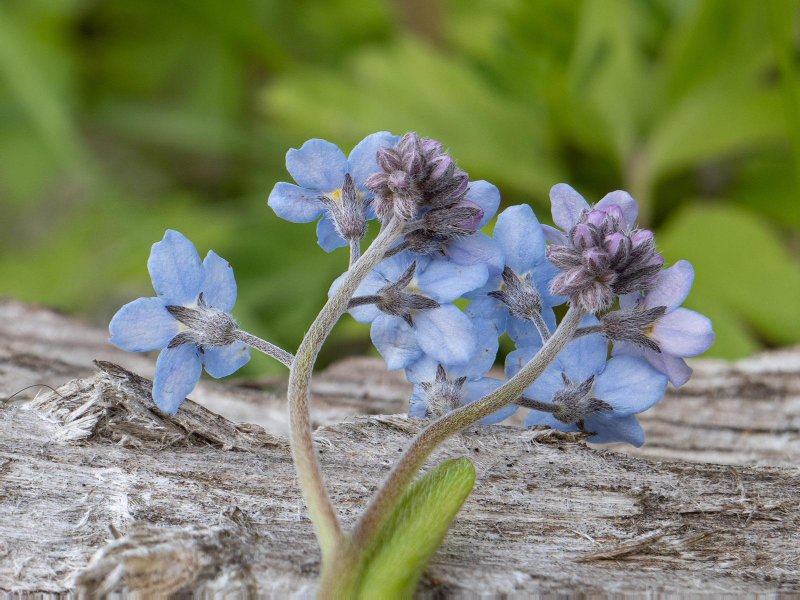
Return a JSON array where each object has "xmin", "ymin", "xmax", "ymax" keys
[{"xmin": 592, "ymin": 356, "xmax": 667, "ymax": 416}]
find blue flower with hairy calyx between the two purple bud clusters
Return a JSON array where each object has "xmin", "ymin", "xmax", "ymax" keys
[{"xmin": 467, "ymin": 204, "xmax": 565, "ymax": 340}]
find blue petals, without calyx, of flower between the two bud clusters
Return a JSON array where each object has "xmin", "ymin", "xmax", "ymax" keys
[{"xmin": 467, "ymin": 204, "xmax": 564, "ymax": 340}]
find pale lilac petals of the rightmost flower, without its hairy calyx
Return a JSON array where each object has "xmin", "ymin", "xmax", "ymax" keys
[{"xmin": 614, "ymin": 260, "xmax": 714, "ymax": 387}]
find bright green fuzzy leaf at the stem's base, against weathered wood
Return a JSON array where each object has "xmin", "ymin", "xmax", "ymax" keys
[{"xmin": 357, "ymin": 458, "xmax": 475, "ymax": 599}]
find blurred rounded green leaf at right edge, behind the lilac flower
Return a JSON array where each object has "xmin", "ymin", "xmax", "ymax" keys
[{"xmin": 659, "ymin": 204, "xmax": 800, "ymax": 358}]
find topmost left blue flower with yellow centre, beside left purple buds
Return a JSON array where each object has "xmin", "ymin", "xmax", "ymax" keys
[{"xmin": 268, "ymin": 131, "xmax": 400, "ymax": 252}]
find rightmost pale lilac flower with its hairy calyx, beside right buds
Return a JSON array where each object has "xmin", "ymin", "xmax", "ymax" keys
[{"xmin": 603, "ymin": 260, "xmax": 714, "ymax": 387}]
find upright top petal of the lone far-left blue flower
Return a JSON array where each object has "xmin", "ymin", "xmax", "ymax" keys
[{"xmin": 147, "ymin": 229, "xmax": 203, "ymax": 305}]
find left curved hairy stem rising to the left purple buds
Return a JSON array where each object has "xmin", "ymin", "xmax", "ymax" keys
[{"xmin": 288, "ymin": 219, "xmax": 402, "ymax": 562}]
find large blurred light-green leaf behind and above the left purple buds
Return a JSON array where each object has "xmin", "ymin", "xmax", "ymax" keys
[{"xmin": 264, "ymin": 38, "xmax": 559, "ymax": 193}]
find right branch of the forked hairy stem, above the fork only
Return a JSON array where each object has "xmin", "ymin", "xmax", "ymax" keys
[{"xmin": 350, "ymin": 306, "xmax": 585, "ymax": 551}]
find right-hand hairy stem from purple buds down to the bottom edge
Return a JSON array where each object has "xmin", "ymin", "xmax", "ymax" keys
[{"xmin": 319, "ymin": 306, "xmax": 585, "ymax": 598}]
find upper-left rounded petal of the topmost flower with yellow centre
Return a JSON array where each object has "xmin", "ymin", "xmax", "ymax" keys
[{"xmin": 286, "ymin": 139, "xmax": 347, "ymax": 193}]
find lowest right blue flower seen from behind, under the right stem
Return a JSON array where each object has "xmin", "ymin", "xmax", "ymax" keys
[{"xmin": 506, "ymin": 324, "xmax": 667, "ymax": 447}]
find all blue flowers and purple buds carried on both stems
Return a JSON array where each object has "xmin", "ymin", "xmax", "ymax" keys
[{"xmin": 110, "ymin": 132, "xmax": 714, "ymax": 445}]
